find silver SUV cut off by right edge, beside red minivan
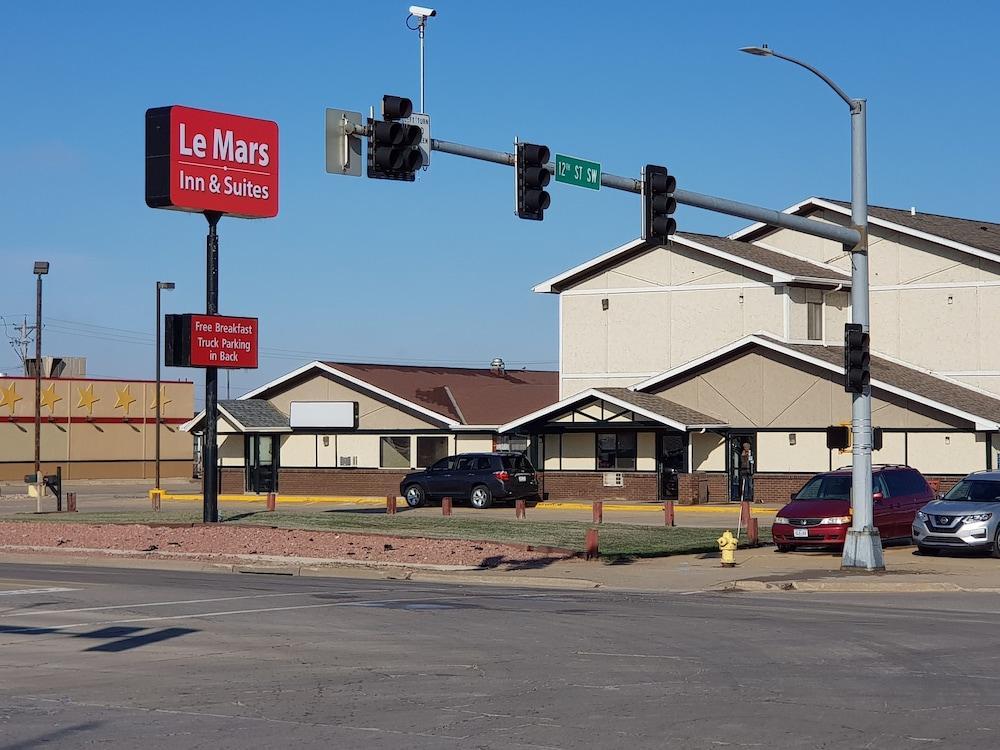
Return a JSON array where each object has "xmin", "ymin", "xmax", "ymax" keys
[{"xmin": 913, "ymin": 471, "xmax": 1000, "ymax": 558}]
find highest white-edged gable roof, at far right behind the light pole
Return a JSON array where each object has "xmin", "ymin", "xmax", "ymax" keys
[{"xmin": 729, "ymin": 197, "xmax": 1000, "ymax": 261}]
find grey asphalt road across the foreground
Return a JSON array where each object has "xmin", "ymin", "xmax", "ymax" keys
[{"xmin": 0, "ymin": 565, "xmax": 1000, "ymax": 750}]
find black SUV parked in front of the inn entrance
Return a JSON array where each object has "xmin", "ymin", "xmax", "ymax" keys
[{"xmin": 399, "ymin": 453, "xmax": 538, "ymax": 509}]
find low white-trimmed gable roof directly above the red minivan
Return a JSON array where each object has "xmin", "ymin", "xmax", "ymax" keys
[{"xmin": 630, "ymin": 333, "xmax": 1000, "ymax": 431}]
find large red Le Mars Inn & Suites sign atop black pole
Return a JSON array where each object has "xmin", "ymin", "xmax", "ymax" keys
[{"xmin": 146, "ymin": 106, "xmax": 278, "ymax": 219}]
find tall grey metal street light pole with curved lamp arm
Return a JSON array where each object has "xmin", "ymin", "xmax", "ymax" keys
[{"xmin": 740, "ymin": 44, "xmax": 885, "ymax": 570}]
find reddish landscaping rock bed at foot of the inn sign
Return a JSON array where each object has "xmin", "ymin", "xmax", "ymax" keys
[{"xmin": 0, "ymin": 522, "xmax": 572, "ymax": 568}]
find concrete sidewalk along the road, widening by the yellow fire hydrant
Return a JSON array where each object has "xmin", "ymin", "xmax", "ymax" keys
[{"xmin": 0, "ymin": 545, "xmax": 1000, "ymax": 595}]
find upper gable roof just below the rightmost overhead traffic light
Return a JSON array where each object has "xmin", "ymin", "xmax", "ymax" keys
[{"xmin": 532, "ymin": 232, "xmax": 851, "ymax": 294}]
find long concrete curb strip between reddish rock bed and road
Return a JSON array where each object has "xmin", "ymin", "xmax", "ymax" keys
[{"xmin": 0, "ymin": 545, "xmax": 601, "ymax": 589}]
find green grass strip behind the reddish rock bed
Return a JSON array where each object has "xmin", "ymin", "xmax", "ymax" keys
[{"xmin": 3, "ymin": 511, "xmax": 771, "ymax": 558}]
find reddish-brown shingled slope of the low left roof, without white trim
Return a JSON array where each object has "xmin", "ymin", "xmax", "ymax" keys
[{"xmin": 324, "ymin": 362, "xmax": 559, "ymax": 425}]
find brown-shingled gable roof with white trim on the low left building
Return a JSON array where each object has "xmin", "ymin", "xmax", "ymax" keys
[{"xmin": 240, "ymin": 361, "xmax": 559, "ymax": 429}]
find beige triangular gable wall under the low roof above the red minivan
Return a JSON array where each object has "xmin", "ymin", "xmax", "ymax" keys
[{"xmin": 654, "ymin": 349, "xmax": 967, "ymax": 429}]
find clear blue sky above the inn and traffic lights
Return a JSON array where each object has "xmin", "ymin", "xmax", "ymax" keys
[{"xmin": 0, "ymin": 0, "xmax": 1000, "ymax": 406}]
